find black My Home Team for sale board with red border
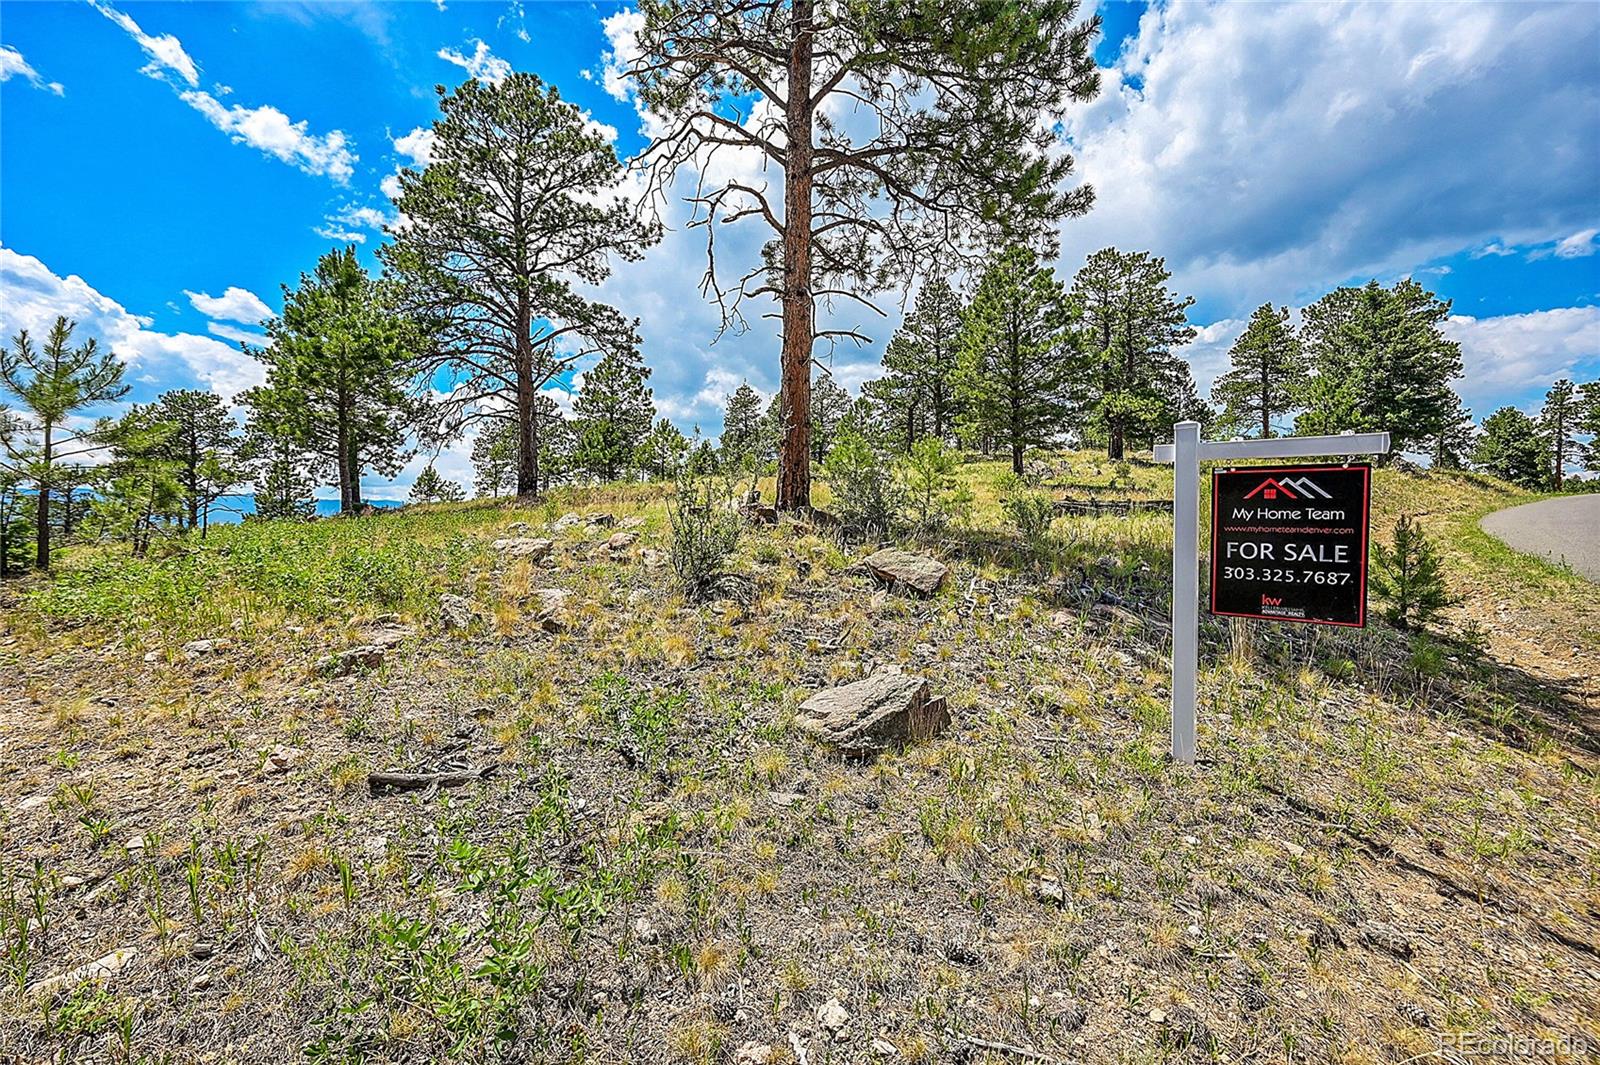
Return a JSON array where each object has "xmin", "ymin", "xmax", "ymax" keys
[{"xmin": 1211, "ymin": 465, "xmax": 1373, "ymax": 627}]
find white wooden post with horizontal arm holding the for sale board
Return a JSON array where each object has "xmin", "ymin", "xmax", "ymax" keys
[{"xmin": 1155, "ymin": 422, "xmax": 1389, "ymax": 766}]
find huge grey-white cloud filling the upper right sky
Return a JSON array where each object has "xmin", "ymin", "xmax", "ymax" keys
[{"xmin": 1062, "ymin": 3, "xmax": 1600, "ymax": 317}]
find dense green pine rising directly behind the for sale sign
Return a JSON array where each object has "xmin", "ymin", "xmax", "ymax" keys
[{"xmin": 1294, "ymin": 278, "xmax": 1461, "ymax": 456}]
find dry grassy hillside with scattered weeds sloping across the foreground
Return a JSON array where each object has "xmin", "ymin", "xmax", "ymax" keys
[{"xmin": 0, "ymin": 456, "xmax": 1600, "ymax": 1062}]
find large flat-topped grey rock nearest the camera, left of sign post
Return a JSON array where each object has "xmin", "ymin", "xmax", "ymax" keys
[{"xmin": 795, "ymin": 670, "xmax": 950, "ymax": 755}]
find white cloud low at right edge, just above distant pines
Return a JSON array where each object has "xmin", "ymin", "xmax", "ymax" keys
[{"xmin": 1443, "ymin": 307, "xmax": 1600, "ymax": 417}]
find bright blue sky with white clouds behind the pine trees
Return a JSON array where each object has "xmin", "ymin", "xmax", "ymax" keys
[{"xmin": 0, "ymin": 0, "xmax": 1600, "ymax": 494}]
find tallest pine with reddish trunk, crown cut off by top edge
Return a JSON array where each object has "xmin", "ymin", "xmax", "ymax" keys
[{"xmin": 627, "ymin": 0, "xmax": 1099, "ymax": 510}]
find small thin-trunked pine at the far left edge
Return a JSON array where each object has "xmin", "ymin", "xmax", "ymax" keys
[{"xmin": 0, "ymin": 317, "xmax": 128, "ymax": 569}]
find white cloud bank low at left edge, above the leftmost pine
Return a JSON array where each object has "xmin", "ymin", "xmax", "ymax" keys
[{"xmin": 0, "ymin": 246, "xmax": 264, "ymax": 398}]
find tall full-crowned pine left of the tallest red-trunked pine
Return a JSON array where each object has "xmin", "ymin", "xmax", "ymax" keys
[{"xmin": 379, "ymin": 72, "xmax": 659, "ymax": 496}]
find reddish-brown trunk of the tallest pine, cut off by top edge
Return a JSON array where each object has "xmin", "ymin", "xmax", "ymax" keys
[{"xmin": 776, "ymin": 0, "xmax": 816, "ymax": 510}]
